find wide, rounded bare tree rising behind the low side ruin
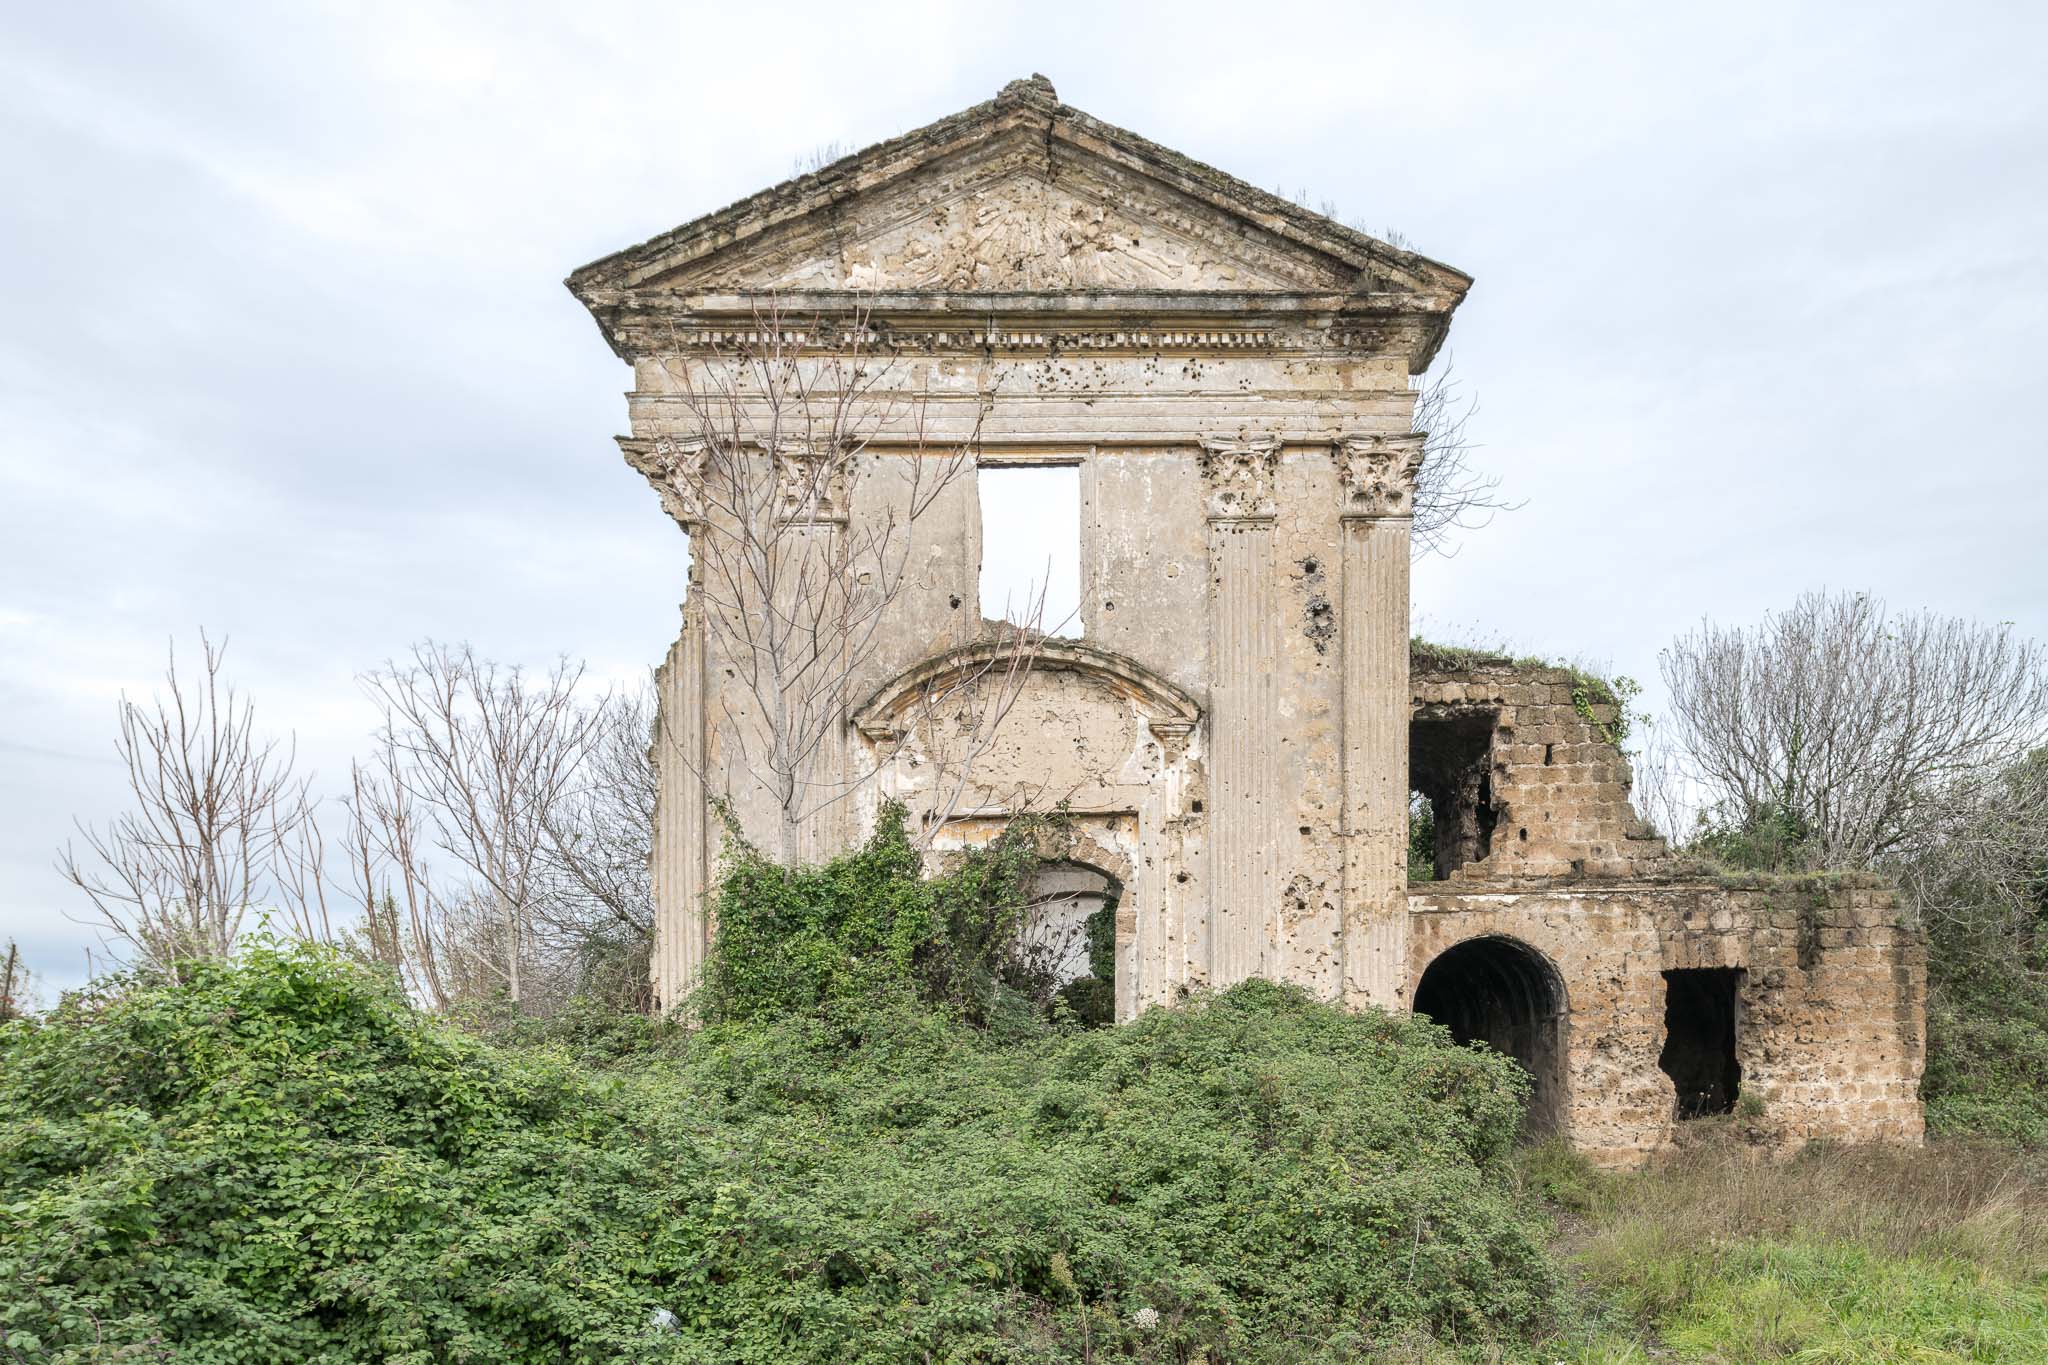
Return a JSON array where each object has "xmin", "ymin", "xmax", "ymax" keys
[{"xmin": 1659, "ymin": 593, "xmax": 2048, "ymax": 868}]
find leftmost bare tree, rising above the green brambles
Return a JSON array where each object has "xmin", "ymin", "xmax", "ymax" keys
[{"xmin": 57, "ymin": 632, "xmax": 311, "ymax": 972}]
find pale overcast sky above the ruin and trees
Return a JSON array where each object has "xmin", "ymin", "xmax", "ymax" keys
[{"xmin": 0, "ymin": 0, "xmax": 2048, "ymax": 984}]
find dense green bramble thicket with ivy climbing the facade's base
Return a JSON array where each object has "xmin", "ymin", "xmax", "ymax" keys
[{"xmin": 0, "ymin": 829, "xmax": 1554, "ymax": 1365}]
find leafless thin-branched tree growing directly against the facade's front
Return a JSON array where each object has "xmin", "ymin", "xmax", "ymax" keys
[{"xmin": 641, "ymin": 303, "xmax": 1040, "ymax": 864}]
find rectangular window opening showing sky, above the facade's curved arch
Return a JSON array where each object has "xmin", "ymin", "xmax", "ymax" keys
[{"xmin": 977, "ymin": 465, "xmax": 1081, "ymax": 639}]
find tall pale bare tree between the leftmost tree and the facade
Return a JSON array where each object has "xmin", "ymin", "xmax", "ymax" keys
[{"xmin": 358, "ymin": 643, "xmax": 594, "ymax": 1005}]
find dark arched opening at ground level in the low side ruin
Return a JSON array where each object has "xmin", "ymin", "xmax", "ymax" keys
[{"xmin": 1415, "ymin": 935, "xmax": 1567, "ymax": 1138}]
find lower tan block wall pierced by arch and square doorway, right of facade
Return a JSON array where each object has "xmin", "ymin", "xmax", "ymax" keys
[{"xmin": 1405, "ymin": 878, "xmax": 1927, "ymax": 1166}]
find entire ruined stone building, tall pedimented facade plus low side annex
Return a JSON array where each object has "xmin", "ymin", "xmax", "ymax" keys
[{"xmin": 569, "ymin": 78, "xmax": 1925, "ymax": 1164}]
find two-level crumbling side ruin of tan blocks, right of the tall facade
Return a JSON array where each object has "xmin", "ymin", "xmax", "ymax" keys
[{"xmin": 1405, "ymin": 647, "xmax": 1927, "ymax": 1166}]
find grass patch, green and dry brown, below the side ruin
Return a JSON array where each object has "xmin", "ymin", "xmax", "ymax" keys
[{"xmin": 1523, "ymin": 1134, "xmax": 2048, "ymax": 1363}]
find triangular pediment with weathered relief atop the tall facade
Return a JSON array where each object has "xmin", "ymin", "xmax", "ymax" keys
[{"xmin": 569, "ymin": 78, "xmax": 1470, "ymax": 305}]
